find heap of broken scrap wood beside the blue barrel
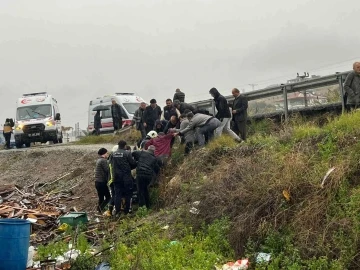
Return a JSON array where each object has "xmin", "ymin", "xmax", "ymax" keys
[{"xmin": 0, "ymin": 185, "xmax": 78, "ymax": 244}]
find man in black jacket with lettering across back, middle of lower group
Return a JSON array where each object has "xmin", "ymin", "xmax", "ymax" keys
[{"xmin": 111, "ymin": 141, "xmax": 136, "ymax": 216}]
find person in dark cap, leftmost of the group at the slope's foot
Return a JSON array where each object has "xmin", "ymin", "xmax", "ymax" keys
[{"xmin": 95, "ymin": 148, "xmax": 111, "ymax": 213}]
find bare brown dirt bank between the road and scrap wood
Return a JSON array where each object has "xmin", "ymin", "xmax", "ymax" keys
[{"xmin": 0, "ymin": 145, "xmax": 113, "ymax": 212}]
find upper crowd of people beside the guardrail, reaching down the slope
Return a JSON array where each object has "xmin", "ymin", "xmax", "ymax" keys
[{"xmin": 133, "ymin": 88, "xmax": 248, "ymax": 156}]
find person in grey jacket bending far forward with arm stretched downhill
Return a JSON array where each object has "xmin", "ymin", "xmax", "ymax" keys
[{"xmin": 176, "ymin": 112, "xmax": 221, "ymax": 146}]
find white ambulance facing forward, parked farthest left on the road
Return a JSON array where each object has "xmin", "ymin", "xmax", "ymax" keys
[{"xmin": 14, "ymin": 92, "xmax": 63, "ymax": 148}]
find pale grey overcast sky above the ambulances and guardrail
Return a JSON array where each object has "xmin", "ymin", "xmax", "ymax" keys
[{"xmin": 0, "ymin": 0, "xmax": 360, "ymax": 129}]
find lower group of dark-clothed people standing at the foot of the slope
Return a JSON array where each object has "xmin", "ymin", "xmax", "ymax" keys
[{"xmin": 95, "ymin": 140, "xmax": 161, "ymax": 217}]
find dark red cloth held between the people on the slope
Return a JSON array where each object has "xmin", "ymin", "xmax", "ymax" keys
[{"xmin": 145, "ymin": 132, "xmax": 174, "ymax": 165}]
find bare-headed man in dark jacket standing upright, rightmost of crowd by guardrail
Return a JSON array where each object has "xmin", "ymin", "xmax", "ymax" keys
[{"xmin": 232, "ymin": 88, "xmax": 248, "ymax": 141}]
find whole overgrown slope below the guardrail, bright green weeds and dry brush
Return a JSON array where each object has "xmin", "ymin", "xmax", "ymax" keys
[{"xmin": 38, "ymin": 112, "xmax": 360, "ymax": 270}]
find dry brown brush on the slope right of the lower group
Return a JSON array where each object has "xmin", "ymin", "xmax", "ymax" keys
[{"xmin": 160, "ymin": 112, "xmax": 360, "ymax": 269}]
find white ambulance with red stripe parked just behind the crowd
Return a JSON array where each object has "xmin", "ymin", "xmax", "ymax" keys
[{"xmin": 87, "ymin": 93, "xmax": 145, "ymax": 134}]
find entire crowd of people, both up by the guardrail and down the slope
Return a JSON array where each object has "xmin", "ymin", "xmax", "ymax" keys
[{"xmin": 95, "ymin": 88, "xmax": 248, "ymax": 217}]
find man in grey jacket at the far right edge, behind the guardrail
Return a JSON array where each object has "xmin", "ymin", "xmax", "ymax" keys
[{"xmin": 344, "ymin": 62, "xmax": 360, "ymax": 109}]
